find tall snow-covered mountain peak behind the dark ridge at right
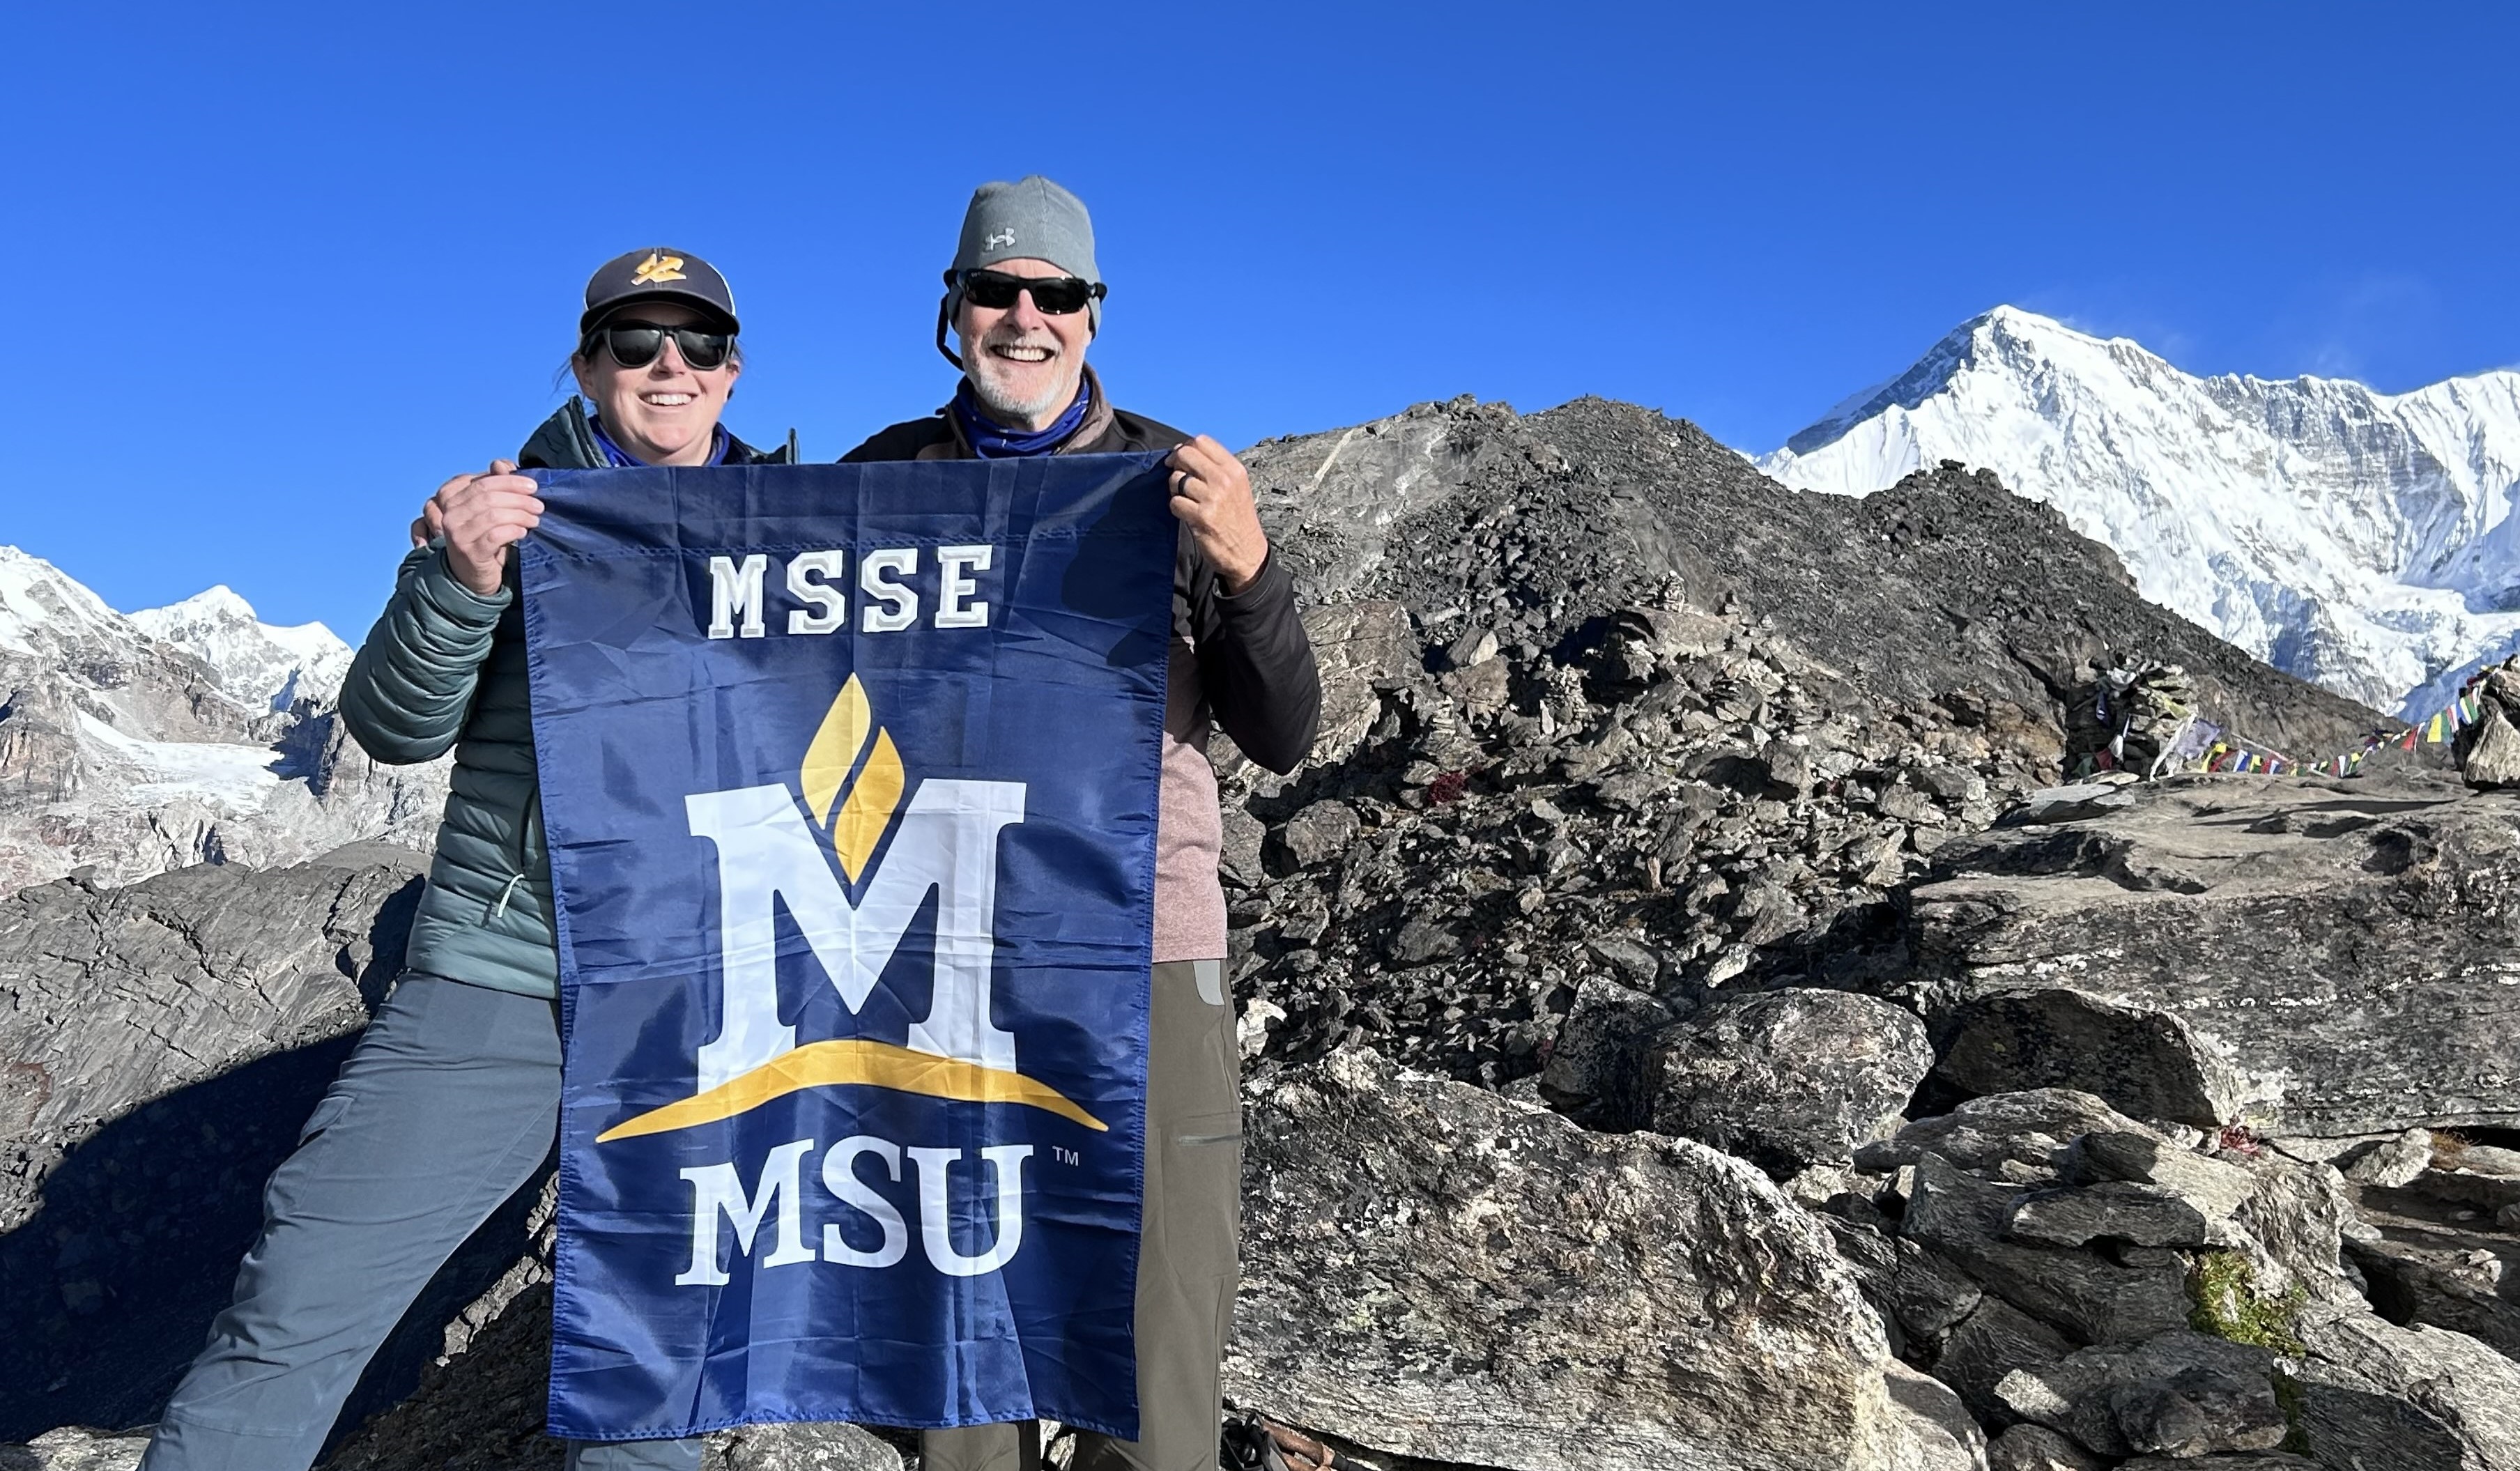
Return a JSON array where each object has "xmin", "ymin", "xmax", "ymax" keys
[{"xmin": 1756, "ymin": 307, "xmax": 2520, "ymax": 716}]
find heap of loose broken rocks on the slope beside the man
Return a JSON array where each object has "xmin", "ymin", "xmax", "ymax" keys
[{"xmin": 1224, "ymin": 587, "xmax": 2054, "ymax": 1103}]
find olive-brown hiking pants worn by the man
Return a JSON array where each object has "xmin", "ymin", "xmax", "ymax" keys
[{"xmin": 920, "ymin": 960, "xmax": 1243, "ymax": 1471}]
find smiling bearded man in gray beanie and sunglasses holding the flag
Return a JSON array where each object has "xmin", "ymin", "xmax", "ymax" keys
[{"xmin": 842, "ymin": 174, "xmax": 1321, "ymax": 1471}]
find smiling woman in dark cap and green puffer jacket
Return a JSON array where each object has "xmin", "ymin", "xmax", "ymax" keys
[{"xmin": 141, "ymin": 247, "xmax": 791, "ymax": 1471}]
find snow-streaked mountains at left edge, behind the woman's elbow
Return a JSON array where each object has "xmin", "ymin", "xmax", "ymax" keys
[{"xmin": 0, "ymin": 546, "xmax": 446, "ymax": 894}]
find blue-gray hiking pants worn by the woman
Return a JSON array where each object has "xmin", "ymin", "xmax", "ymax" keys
[{"xmin": 141, "ymin": 975, "xmax": 700, "ymax": 1471}]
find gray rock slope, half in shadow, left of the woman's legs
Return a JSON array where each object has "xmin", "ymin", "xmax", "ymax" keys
[{"xmin": 0, "ymin": 849, "xmax": 423, "ymax": 1443}]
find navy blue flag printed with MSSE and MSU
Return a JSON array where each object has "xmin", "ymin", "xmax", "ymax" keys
[{"xmin": 519, "ymin": 456, "xmax": 1177, "ymax": 1441}]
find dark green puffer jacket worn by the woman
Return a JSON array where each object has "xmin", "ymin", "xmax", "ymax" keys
[{"xmin": 340, "ymin": 398, "xmax": 789, "ymax": 995}]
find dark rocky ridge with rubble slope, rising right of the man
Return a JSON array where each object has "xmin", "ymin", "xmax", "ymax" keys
[{"xmin": 1224, "ymin": 401, "xmax": 2374, "ymax": 1098}]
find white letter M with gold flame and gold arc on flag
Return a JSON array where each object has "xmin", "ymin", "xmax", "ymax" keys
[{"xmin": 597, "ymin": 675, "xmax": 1106, "ymax": 1143}]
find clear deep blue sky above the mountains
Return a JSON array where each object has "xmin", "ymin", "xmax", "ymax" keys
[{"xmin": 0, "ymin": 0, "xmax": 2520, "ymax": 642}]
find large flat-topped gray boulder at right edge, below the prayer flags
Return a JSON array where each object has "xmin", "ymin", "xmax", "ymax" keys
[{"xmin": 1913, "ymin": 776, "xmax": 2520, "ymax": 1136}]
